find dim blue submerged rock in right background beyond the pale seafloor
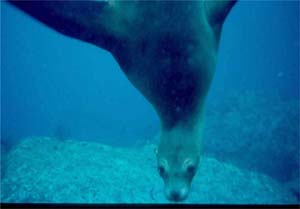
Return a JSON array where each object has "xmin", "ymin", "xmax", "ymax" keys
[{"xmin": 203, "ymin": 90, "xmax": 300, "ymax": 183}]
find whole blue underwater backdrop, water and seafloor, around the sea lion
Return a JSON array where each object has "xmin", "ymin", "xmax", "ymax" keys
[{"xmin": 1, "ymin": 1, "xmax": 300, "ymax": 204}]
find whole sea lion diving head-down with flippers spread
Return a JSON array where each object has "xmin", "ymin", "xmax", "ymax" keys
[{"xmin": 9, "ymin": 0, "xmax": 235, "ymax": 201}]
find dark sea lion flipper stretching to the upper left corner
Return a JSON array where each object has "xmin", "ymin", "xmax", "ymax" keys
[{"xmin": 8, "ymin": 0, "xmax": 117, "ymax": 51}]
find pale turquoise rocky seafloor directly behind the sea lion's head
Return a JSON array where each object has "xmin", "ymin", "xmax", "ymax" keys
[{"xmin": 1, "ymin": 137, "xmax": 299, "ymax": 204}]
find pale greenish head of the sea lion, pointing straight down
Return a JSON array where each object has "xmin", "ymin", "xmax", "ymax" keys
[{"xmin": 157, "ymin": 128, "xmax": 200, "ymax": 201}]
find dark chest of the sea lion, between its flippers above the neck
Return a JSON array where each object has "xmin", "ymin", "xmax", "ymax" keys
[{"xmin": 111, "ymin": 3, "xmax": 216, "ymax": 127}]
